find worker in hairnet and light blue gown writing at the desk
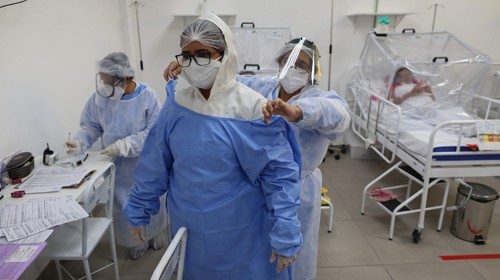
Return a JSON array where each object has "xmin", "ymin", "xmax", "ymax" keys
[{"xmin": 65, "ymin": 52, "xmax": 167, "ymax": 259}]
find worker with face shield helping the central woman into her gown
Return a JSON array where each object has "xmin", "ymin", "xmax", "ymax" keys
[{"xmin": 164, "ymin": 38, "xmax": 350, "ymax": 280}]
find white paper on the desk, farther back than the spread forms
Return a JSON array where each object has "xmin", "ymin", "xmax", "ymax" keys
[{"xmin": 21, "ymin": 167, "xmax": 88, "ymax": 193}]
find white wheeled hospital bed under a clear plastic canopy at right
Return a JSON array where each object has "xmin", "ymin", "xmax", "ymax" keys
[{"xmin": 347, "ymin": 30, "xmax": 500, "ymax": 243}]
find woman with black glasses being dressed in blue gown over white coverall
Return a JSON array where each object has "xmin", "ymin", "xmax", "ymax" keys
[{"xmin": 124, "ymin": 13, "xmax": 302, "ymax": 280}]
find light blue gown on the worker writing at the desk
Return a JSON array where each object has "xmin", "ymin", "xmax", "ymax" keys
[{"xmin": 74, "ymin": 83, "xmax": 167, "ymax": 247}]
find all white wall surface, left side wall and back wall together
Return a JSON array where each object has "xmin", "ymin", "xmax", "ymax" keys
[{"xmin": 0, "ymin": 0, "xmax": 500, "ymax": 156}]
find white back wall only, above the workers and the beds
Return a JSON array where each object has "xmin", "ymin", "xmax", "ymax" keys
[{"xmin": 122, "ymin": 0, "xmax": 500, "ymax": 97}]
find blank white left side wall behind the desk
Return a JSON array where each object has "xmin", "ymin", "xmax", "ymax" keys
[{"xmin": 0, "ymin": 0, "xmax": 128, "ymax": 157}]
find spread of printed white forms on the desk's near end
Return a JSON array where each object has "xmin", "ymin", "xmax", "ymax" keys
[{"xmin": 0, "ymin": 197, "xmax": 88, "ymax": 242}]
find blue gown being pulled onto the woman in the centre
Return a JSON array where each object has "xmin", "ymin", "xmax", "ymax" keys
[{"xmin": 124, "ymin": 82, "xmax": 302, "ymax": 280}]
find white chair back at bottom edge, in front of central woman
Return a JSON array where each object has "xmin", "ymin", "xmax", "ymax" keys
[{"xmin": 151, "ymin": 227, "xmax": 187, "ymax": 280}]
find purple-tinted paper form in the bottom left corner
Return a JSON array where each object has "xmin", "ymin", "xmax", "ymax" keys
[{"xmin": 0, "ymin": 243, "xmax": 46, "ymax": 280}]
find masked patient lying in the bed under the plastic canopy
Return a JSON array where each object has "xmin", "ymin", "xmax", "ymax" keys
[{"xmin": 389, "ymin": 67, "xmax": 476, "ymax": 136}]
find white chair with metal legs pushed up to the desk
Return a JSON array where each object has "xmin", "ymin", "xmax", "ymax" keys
[{"xmin": 44, "ymin": 163, "xmax": 120, "ymax": 280}]
